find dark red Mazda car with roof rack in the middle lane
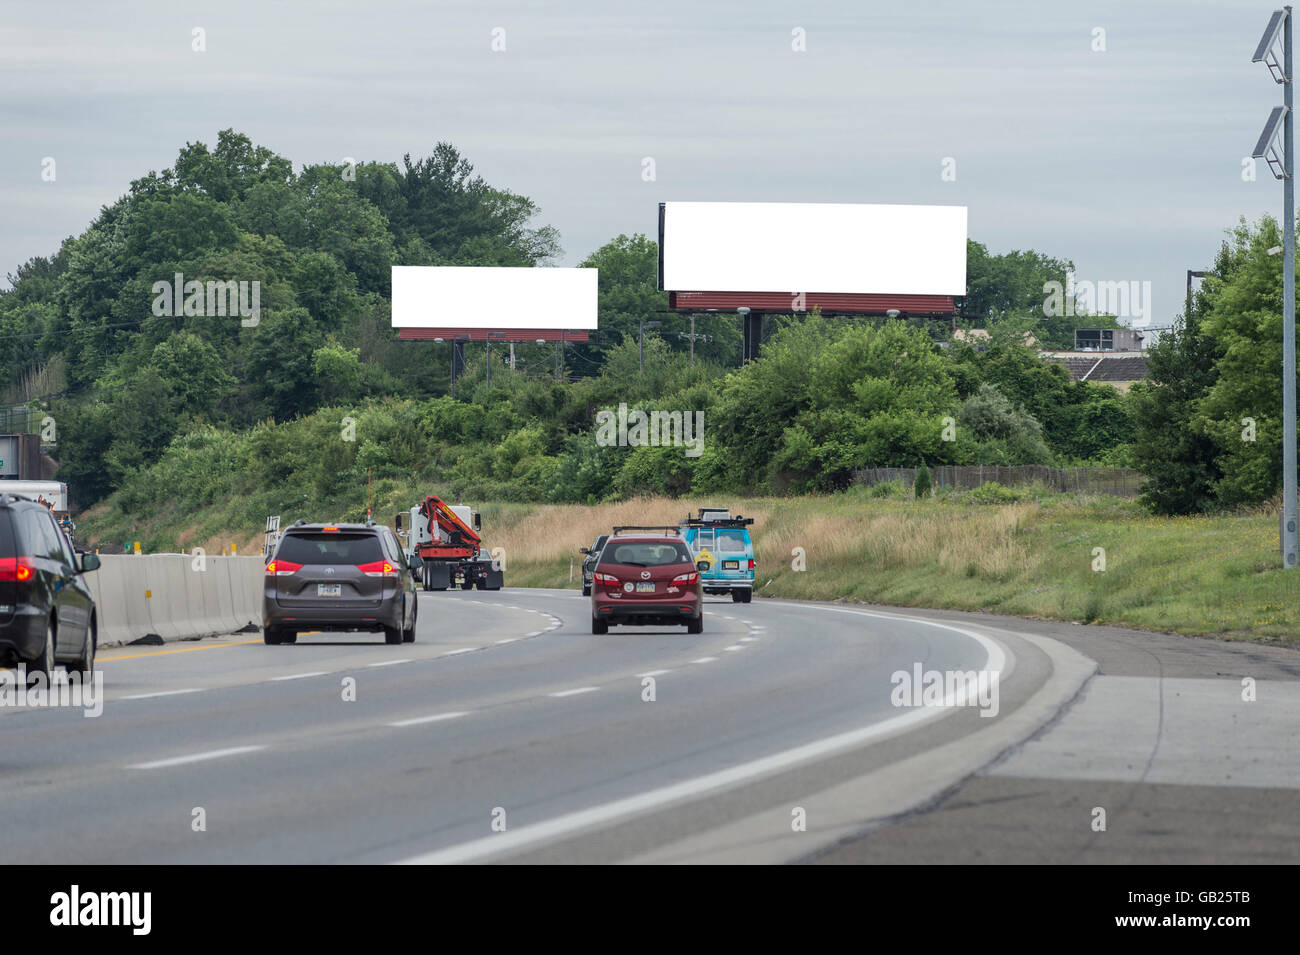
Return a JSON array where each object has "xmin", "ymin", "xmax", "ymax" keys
[{"xmin": 592, "ymin": 528, "xmax": 705, "ymax": 633}]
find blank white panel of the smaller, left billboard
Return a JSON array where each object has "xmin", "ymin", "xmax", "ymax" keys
[{"xmin": 393, "ymin": 265, "xmax": 598, "ymax": 329}]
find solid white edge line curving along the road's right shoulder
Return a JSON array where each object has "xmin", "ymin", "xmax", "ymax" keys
[{"xmin": 398, "ymin": 607, "xmax": 1006, "ymax": 865}]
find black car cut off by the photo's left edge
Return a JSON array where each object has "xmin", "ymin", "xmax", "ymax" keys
[{"xmin": 0, "ymin": 492, "xmax": 99, "ymax": 680}]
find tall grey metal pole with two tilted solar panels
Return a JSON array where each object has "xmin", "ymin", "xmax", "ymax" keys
[{"xmin": 1251, "ymin": 6, "xmax": 1300, "ymax": 570}]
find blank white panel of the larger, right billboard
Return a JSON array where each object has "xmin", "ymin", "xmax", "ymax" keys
[{"xmin": 660, "ymin": 203, "xmax": 966, "ymax": 295}]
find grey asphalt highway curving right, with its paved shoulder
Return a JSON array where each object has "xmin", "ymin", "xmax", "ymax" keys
[{"xmin": 0, "ymin": 589, "xmax": 1300, "ymax": 864}]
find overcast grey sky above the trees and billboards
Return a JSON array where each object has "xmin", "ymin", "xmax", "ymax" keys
[{"xmin": 0, "ymin": 0, "xmax": 1282, "ymax": 326}]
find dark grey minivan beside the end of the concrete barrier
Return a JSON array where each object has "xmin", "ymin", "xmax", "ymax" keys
[{"xmin": 261, "ymin": 521, "xmax": 419, "ymax": 643}]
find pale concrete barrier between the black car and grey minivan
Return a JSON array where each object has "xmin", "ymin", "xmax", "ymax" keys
[{"xmin": 86, "ymin": 554, "xmax": 264, "ymax": 647}]
